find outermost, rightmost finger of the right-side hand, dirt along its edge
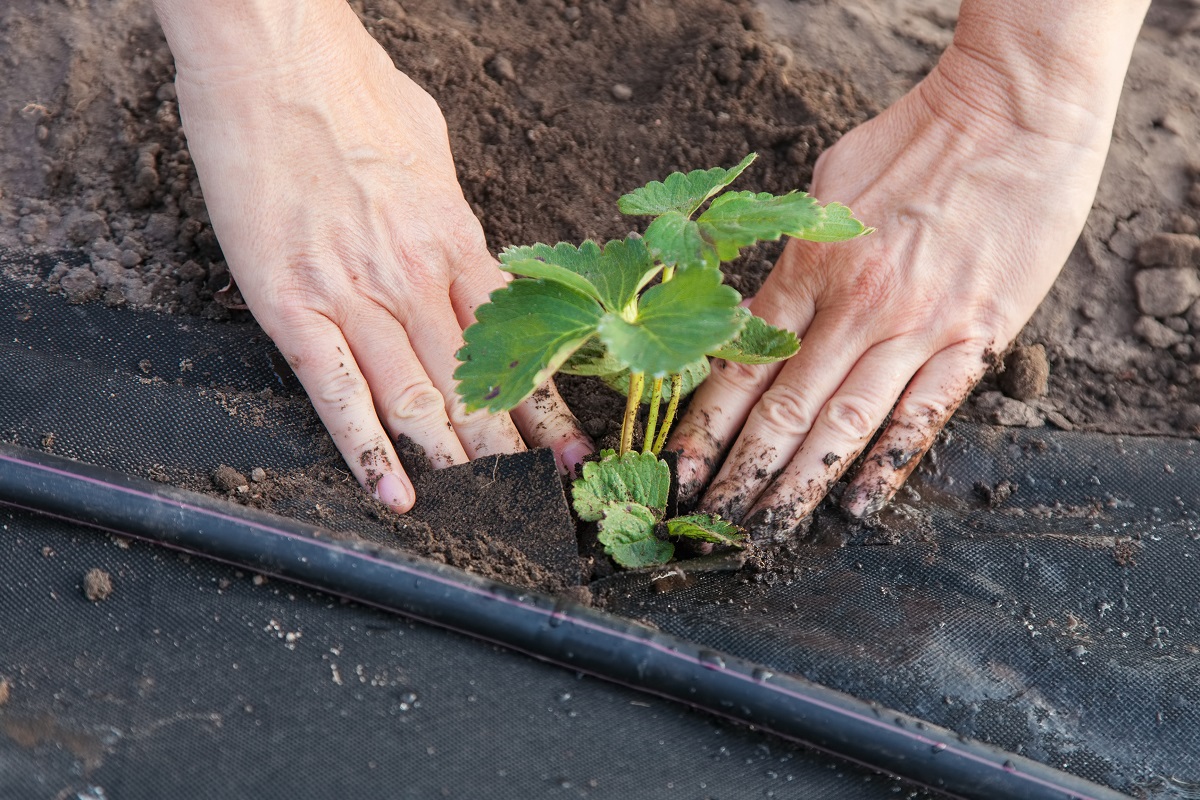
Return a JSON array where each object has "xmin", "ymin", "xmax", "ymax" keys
[{"xmin": 841, "ymin": 343, "xmax": 986, "ymax": 518}]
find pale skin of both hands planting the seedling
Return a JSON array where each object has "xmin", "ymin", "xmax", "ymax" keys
[{"xmin": 155, "ymin": 0, "xmax": 1148, "ymax": 522}]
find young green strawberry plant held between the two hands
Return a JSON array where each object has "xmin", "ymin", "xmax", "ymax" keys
[{"xmin": 455, "ymin": 154, "xmax": 871, "ymax": 567}]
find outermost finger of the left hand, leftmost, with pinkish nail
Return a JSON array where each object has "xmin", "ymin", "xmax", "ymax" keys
[{"xmin": 271, "ymin": 313, "xmax": 416, "ymax": 513}]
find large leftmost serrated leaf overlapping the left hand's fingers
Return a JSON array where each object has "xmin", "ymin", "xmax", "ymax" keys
[{"xmin": 454, "ymin": 278, "xmax": 604, "ymax": 411}]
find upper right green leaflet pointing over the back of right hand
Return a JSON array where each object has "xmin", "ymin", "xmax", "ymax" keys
[{"xmin": 696, "ymin": 192, "xmax": 872, "ymax": 261}]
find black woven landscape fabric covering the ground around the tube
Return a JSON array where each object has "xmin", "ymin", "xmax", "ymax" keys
[{"xmin": 0, "ymin": 253, "xmax": 1200, "ymax": 800}]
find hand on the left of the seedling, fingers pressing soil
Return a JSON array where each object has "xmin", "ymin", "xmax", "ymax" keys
[{"xmin": 157, "ymin": 0, "xmax": 592, "ymax": 512}]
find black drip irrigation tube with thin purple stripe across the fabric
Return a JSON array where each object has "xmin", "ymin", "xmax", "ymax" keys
[{"xmin": 0, "ymin": 444, "xmax": 1126, "ymax": 800}]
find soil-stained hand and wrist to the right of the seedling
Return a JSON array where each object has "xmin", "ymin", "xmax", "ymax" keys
[{"xmin": 668, "ymin": 2, "xmax": 1145, "ymax": 536}]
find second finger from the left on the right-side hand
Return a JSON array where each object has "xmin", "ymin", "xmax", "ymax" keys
[{"xmin": 701, "ymin": 314, "xmax": 883, "ymax": 521}]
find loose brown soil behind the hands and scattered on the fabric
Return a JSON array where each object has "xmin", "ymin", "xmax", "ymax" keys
[{"xmin": 0, "ymin": 0, "xmax": 1200, "ymax": 588}]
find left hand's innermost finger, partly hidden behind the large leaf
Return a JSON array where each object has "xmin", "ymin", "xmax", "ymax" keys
[{"xmin": 450, "ymin": 262, "xmax": 595, "ymax": 474}]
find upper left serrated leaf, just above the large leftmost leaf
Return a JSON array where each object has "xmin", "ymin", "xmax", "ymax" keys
[{"xmin": 500, "ymin": 236, "xmax": 662, "ymax": 314}]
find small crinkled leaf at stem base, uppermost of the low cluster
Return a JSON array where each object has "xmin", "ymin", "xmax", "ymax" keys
[{"xmin": 571, "ymin": 452, "xmax": 671, "ymax": 522}]
